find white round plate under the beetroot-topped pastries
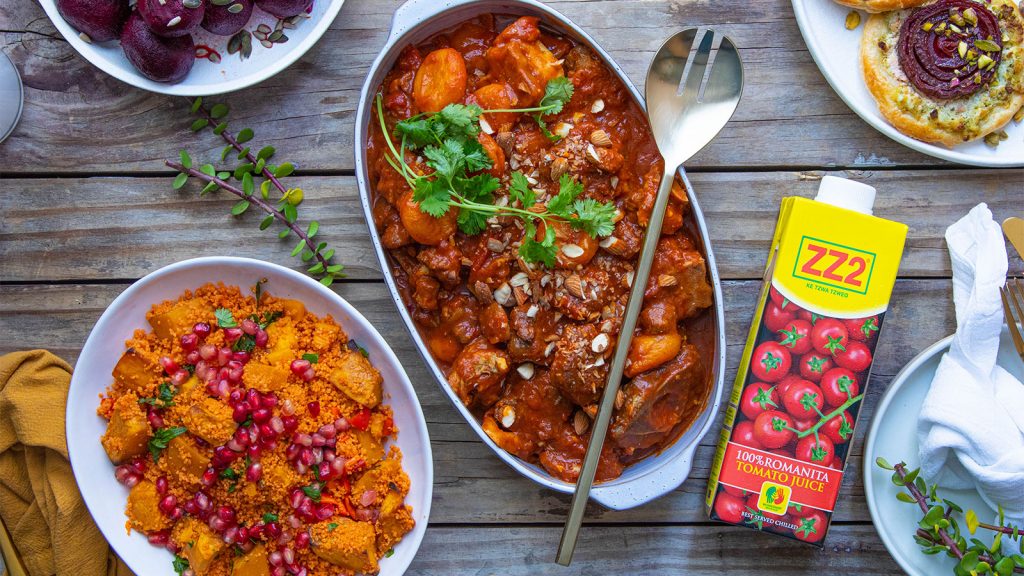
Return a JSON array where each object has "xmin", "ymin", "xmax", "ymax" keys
[{"xmin": 793, "ymin": 0, "xmax": 1024, "ymax": 167}]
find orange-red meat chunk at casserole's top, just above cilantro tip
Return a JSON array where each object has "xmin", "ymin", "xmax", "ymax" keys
[{"xmin": 486, "ymin": 16, "xmax": 563, "ymax": 108}]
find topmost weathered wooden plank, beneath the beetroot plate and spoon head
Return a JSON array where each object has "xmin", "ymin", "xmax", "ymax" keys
[{"xmin": 0, "ymin": 0, "xmax": 958, "ymax": 173}]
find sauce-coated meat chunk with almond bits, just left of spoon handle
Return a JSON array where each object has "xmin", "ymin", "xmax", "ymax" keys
[{"xmin": 551, "ymin": 324, "xmax": 610, "ymax": 406}]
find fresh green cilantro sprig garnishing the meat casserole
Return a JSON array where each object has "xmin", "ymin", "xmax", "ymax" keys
[{"xmin": 377, "ymin": 77, "xmax": 615, "ymax": 268}]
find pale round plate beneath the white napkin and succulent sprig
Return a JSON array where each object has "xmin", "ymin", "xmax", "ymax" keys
[{"xmin": 863, "ymin": 327, "xmax": 1024, "ymax": 576}]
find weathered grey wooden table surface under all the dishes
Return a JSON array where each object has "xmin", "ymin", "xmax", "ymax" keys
[{"xmin": 0, "ymin": 0, "xmax": 1024, "ymax": 575}]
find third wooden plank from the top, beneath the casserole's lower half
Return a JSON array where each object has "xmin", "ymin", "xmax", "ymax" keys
[{"xmin": 0, "ymin": 280, "xmax": 955, "ymax": 523}]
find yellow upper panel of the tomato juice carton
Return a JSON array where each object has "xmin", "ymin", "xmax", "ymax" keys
[{"xmin": 772, "ymin": 198, "xmax": 906, "ymax": 318}]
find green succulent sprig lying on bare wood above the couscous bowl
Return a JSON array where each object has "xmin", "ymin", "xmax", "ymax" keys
[{"xmin": 164, "ymin": 98, "xmax": 344, "ymax": 286}]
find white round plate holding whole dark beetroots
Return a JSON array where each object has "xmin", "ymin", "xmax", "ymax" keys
[{"xmin": 40, "ymin": 0, "xmax": 345, "ymax": 96}]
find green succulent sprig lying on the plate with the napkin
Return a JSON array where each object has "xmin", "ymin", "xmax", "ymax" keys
[{"xmin": 874, "ymin": 457, "xmax": 1024, "ymax": 576}]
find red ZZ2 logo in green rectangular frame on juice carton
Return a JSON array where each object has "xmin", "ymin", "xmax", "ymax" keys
[{"xmin": 794, "ymin": 236, "xmax": 874, "ymax": 293}]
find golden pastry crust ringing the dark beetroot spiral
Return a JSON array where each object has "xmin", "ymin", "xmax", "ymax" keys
[{"xmin": 860, "ymin": 0, "xmax": 1024, "ymax": 147}]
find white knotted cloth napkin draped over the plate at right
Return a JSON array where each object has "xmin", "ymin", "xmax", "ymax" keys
[{"xmin": 918, "ymin": 203, "xmax": 1024, "ymax": 541}]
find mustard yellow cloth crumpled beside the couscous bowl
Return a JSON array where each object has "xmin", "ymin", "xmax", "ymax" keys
[{"xmin": 0, "ymin": 351, "xmax": 132, "ymax": 576}]
